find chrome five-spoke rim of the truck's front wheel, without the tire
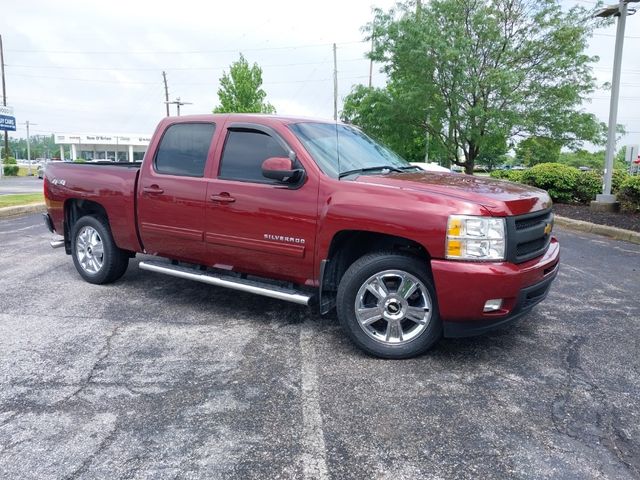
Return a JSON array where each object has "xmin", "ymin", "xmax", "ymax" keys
[{"xmin": 355, "ymin": 270, "xmax": 432, "ymax": 345}]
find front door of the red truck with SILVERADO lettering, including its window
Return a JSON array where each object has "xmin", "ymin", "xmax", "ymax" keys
[{"xmin": 205, "ymin": 123, "xmax": 318, "ymax": 283}]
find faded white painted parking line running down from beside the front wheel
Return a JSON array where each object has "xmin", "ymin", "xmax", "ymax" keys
[{"xmin": 300, "ymin": 321, "xmax": 329, "ymax": 480}]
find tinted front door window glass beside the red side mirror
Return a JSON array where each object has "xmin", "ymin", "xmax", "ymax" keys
[{"xmin": 219, "ymin": 130, "xmax": 287, "ymax": 183}]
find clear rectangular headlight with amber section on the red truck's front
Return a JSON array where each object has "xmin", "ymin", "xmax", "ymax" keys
[{"xmin": 446, "ymin": 215, "xmax": 506, "ymax": 260}]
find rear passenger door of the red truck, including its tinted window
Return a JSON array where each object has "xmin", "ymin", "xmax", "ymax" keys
[{"xmin": 138, "ymin": 122, "xmax": 215, "ymax": 263}]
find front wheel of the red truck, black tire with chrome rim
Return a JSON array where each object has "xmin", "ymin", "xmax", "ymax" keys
[{"xmin": 337, "ymin": 252, "xmax": 442, "ymax": 358}]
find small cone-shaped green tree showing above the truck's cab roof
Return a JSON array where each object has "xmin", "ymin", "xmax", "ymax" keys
[{"xmin": 213, "ymin": 54, "xmax": 276, "ymax": 113}]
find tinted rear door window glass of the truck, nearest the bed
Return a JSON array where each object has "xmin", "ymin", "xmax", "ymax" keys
[{"xmin": 155, "ymin": 123, "xmax": 216, "ymax": 177}]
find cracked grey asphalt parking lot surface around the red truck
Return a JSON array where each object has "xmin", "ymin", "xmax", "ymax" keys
[{"xmin": 0, "ymin": 216, "xmax": 640, "ymax": 480}]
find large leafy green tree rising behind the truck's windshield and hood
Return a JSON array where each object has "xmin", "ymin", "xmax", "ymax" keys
[{"xmin": 343, "ymin": 0, "xmax": 605, "ymax": 173}]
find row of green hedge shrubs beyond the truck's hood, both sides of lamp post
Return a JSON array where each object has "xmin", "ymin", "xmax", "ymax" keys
[{"xmin": 491, "ymin": 163, "xmax": 640, "ymax": 211}]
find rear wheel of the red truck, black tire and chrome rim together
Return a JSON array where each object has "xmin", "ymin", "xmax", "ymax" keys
[{"xmin": 71, "ymin": 215, "xmax": 129, "ymax": 284}]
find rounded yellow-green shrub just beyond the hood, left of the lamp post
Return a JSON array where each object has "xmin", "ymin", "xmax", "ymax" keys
[{"xmin": 522, "ymin": 163, "xmax": 580, "ymax": 203}]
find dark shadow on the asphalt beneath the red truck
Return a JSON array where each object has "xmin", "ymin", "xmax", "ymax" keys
[{"xmin": 114, "ymin": 260, "xmax": 539, "ymax": 363}]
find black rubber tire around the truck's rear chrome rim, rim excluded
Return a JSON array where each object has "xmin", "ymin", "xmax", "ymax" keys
[{"xmin": 71, "ymin": 215, "xmax": 129, "ymax": 285}]
